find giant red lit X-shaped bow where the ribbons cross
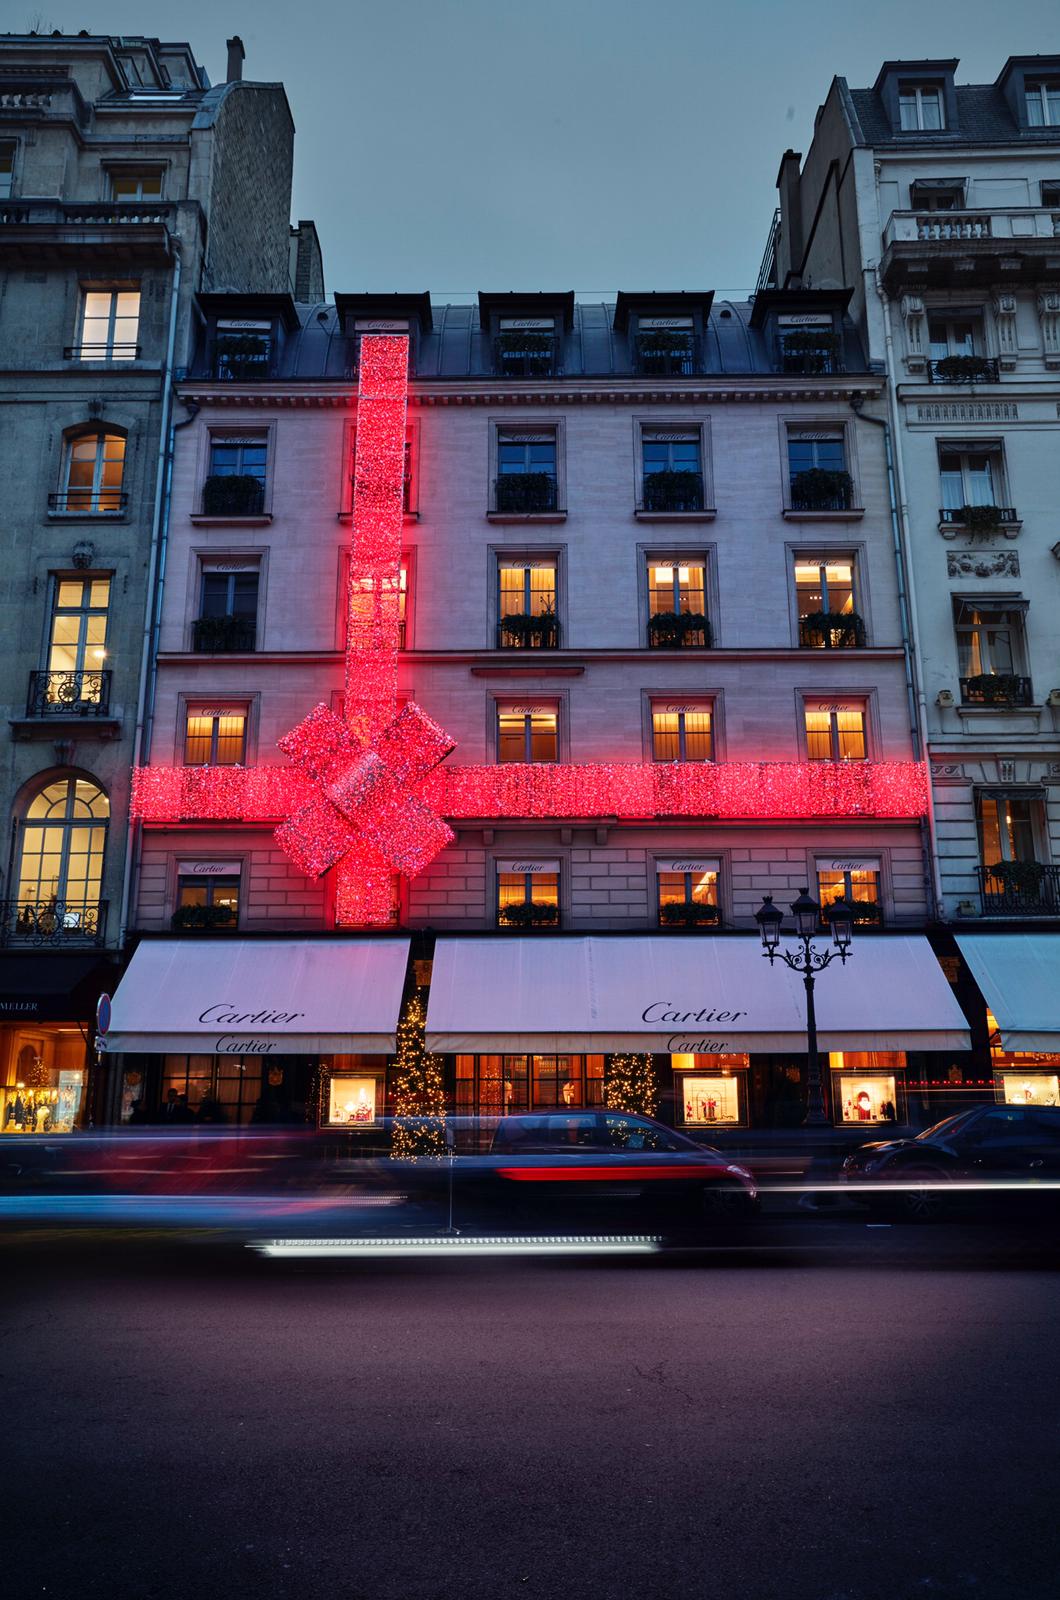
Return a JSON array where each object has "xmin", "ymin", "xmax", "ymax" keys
[{"xmin": 275, "ymin": 704, "xmax": 455, "ymax": 878}]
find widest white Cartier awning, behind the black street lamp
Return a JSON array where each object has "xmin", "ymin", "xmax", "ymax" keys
[{"xmin": 428, "ymin": 934, "xmax": 970, "ymax": 1054}]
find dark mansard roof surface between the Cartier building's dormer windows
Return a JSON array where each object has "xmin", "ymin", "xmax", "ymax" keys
[{"xmin": 191, "ymin": 290, "xmax": 868, "ymax": 382}]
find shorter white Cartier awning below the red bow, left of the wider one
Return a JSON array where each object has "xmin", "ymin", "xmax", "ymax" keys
[{"xmin": 107, "ymin": 938, "xmax": 408, "ymax": 1056}]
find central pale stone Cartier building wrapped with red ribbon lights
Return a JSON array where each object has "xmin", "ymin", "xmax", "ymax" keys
[{"xmin": 112, "ymin": 290, "xmax": 967, "ymax": 1128}]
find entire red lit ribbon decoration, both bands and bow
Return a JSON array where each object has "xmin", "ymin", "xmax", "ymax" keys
[{"xmin": 131, "ymin": 334, "xmax": 927, "ymax": 926}]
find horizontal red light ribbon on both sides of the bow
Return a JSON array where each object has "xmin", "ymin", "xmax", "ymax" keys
[{"xmin": 133, "ymin": 762, "xmax": 927, "ymax": 822}]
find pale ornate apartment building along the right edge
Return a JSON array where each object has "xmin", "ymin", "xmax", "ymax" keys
[{"xmin": 762, "ymin": 56, "xmax": 1060, "ymax": 1102}]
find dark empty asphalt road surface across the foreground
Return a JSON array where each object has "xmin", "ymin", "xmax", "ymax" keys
[{"xmin": 0, "ymin": 1218, "xmax": 1060, "ymax": 1600}]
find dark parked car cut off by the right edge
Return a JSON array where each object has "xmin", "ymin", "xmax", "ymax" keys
[{"xmin": 842, "ymin": 1106, "xmax": 1060, "ymax": 1218}]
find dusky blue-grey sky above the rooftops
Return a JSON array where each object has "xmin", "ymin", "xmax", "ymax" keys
[{"xmin": 47, "ymin": 0, "xmax": 1060, "ymax": 298}]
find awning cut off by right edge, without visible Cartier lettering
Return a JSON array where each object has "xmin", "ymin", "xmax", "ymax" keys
[{"xmin": 958, "ymin": 933, "xmax": 1060, "ymax": 1054}]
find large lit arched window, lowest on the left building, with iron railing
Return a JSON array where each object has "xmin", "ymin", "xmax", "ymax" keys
[{"xmin": 13, "ymin": 778, "xmax": 110, "ymax": 942}]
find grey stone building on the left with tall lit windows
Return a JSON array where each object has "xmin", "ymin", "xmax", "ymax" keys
[{"xmin": 0, "ymin": 32, "xmax": 319, "ymax": 1130}]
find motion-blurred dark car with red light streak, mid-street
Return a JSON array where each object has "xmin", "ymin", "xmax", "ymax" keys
[{"xmin": 488, "ymin": 1110, "xmax": 757, "ymax": 1232}]
